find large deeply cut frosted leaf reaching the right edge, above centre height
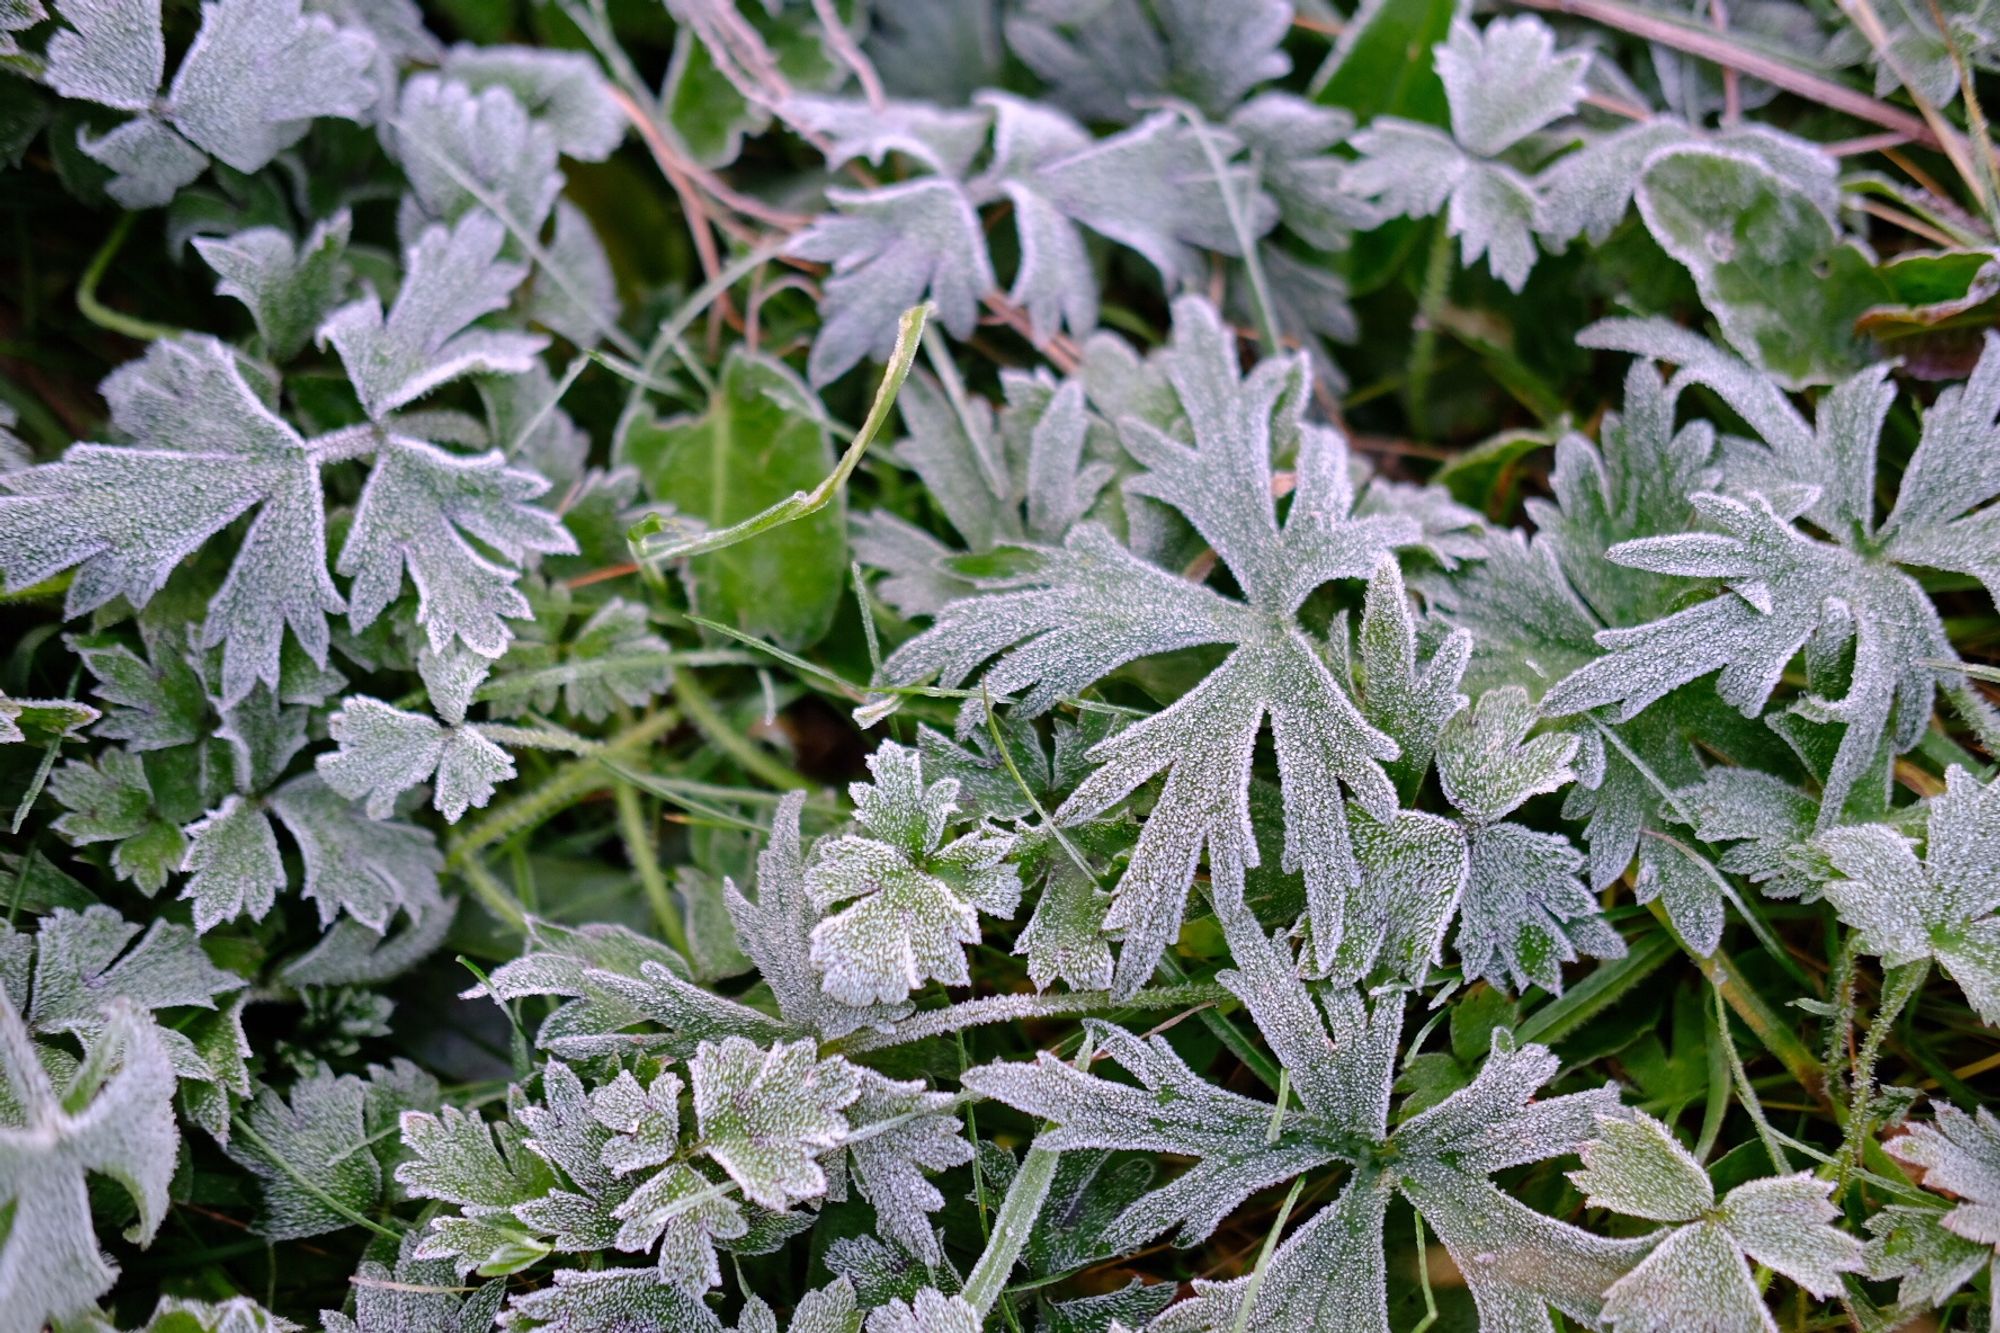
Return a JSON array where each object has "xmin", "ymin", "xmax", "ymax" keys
[{"xmin": 1542, "ymin": 320, "xmax": 2000, "ymax": 827}]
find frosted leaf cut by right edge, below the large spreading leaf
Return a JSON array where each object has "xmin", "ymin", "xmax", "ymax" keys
[{"xmin": 1812, "ymin": 765, "xmax": 2000, "ymax": 1023}]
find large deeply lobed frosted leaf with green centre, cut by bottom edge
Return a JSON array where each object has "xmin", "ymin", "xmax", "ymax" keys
[{"xmin": 964, "ymin": 903, "xmax": 1648, "ymax": 1333}]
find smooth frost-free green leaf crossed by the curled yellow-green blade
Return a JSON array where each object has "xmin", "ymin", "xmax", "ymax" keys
[{"xmin": 620, "ymin": 348, "xmax": 848, "ymax": 648}]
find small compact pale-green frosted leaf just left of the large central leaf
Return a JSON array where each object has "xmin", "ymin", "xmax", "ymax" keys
[{"xmin": 806, "ymin": 743, "xmax": 1022, "ymax": 1005}]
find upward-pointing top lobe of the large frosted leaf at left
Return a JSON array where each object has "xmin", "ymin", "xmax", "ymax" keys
[{"xmin": 320, "ymin": 214, "xmax": 548, "ymax": 420}]
